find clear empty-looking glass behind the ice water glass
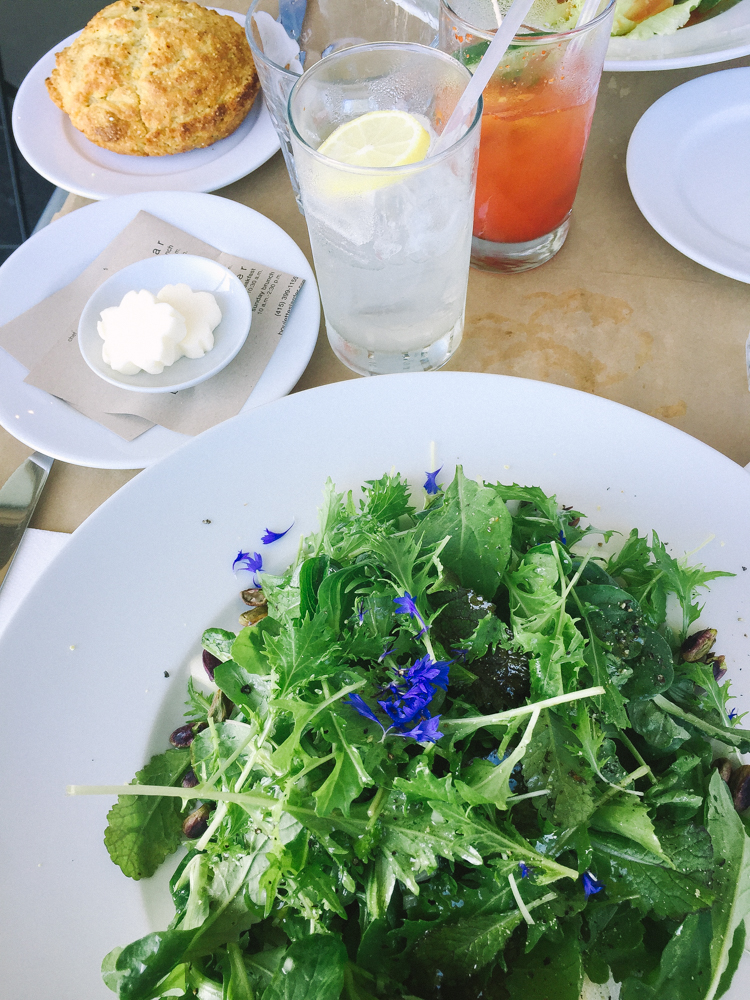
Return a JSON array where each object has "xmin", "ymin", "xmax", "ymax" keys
[{"xmin": 245, "ymin": 0, "xmax": 438, "ymax": 211}]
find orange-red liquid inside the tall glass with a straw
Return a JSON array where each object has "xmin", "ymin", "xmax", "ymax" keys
[{"xmin": 474, "ymin": 81, "xmax": 596, "ymax": 243}]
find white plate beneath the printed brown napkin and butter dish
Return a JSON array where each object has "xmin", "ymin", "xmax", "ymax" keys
[{"xmin": 0, "ymin": 191, "xmax": 320, "ymax": 469}]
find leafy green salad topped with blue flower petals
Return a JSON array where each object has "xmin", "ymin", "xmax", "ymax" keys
[{"xmin": 82, "ymin": 467, "xmax": 750, "ymax": 1000}]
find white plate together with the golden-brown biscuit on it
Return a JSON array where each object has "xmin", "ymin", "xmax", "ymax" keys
[{"xmin": 12, "ymin": 0, "xmax": 279, "ymax": 199}]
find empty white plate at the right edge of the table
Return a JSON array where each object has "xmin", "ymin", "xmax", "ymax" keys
[{"xmin": 627, "ymin": 68, "xmax": 750, "ymax": 282}]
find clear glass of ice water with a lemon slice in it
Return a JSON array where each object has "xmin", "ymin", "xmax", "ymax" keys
[{"xmin": 289, "ymin": 42, "xmax": 482, "ymax": 375}]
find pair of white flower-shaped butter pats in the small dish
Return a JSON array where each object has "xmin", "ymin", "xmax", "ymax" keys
[{"xmin": 96, "ymin": 284, "xmax": 221, "ymax": 375}]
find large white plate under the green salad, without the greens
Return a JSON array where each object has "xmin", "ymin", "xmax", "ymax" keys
[{"xmin": 0, "ymin": 372, "xmax": 750, "ymax": 1000}]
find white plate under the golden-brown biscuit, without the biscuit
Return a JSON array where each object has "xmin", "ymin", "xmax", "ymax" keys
[{"xmin": 12, "ymin": 7, "xmax": 279, "ymax": 199}]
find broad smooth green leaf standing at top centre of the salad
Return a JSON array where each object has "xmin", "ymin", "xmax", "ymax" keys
[{"xmin": 422, "ymin": 465, "xmax": 512, "ymax": 601}]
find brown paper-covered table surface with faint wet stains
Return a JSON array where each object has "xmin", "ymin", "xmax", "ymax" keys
[{"xmin": 0, "ymin": 0, "xmax": 750, "ymax": 531}]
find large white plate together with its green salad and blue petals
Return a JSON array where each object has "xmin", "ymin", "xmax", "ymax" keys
[{"xmin": 0, "ymin": 372, "xmax": 750, "ymax": 1000}]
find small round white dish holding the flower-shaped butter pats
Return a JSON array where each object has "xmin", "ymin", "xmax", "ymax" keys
[{"xmin": 78, "ymin": 254, "xmax": 253, "ymax": 392}]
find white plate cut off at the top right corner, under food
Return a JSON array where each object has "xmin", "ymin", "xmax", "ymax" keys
[{"xmin": 604, "ymin": 0, "xmax": 750, "ymax": 73}]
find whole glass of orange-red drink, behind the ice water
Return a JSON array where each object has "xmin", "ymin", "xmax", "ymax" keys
[{"xmin": 440, "ymin": 0, "xmax": 614, "ymax": 271}]
